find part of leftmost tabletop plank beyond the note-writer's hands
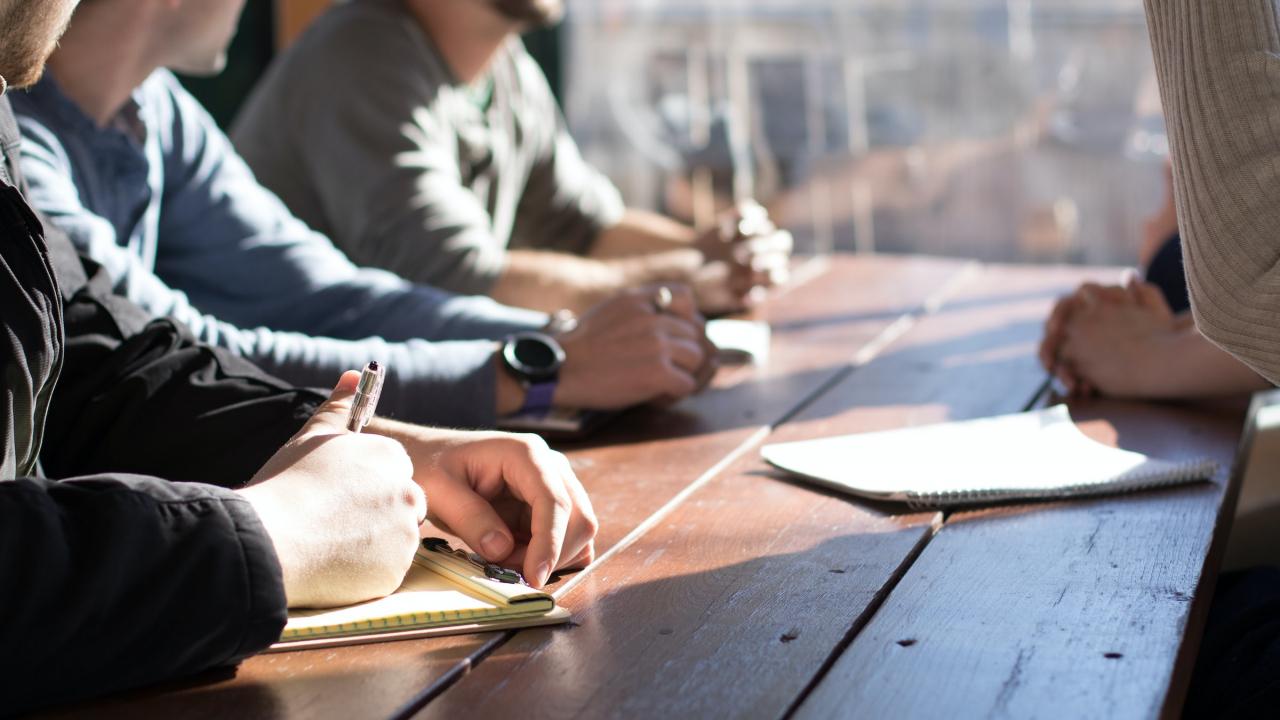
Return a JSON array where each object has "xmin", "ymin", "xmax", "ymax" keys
[{"xmin": 561, "ymin": 256, "xmax": 968, "ymax": 553}]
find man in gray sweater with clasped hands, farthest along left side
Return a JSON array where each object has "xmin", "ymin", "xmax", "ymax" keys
[{"xmin": 233, "ymin": 0, "xmax": 791, "ymax": 313}]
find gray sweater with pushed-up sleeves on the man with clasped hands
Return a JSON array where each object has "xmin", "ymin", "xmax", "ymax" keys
[{"xmin": 232, "ymin": 0, "xmax": 623, "ymax": 295}]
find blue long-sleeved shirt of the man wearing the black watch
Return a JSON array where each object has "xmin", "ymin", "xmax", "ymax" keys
[{"xmin": 13, "ymin": 70, "xmax": 547, "ymax": 425}]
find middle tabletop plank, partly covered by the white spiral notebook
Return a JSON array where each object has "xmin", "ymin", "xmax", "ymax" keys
[{"xmin": 417, "ymin": 260, "xmax": 1111, "ymax": 717}]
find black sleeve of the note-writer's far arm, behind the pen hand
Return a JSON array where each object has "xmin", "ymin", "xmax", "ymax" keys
[{"xmin": 41, "ymin": 223, "xmax": 327, "ymax": 487}]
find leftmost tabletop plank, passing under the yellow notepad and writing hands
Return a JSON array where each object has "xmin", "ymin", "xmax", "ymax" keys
[{"xmin": 45, "ymin": 258, "xmax": 965, "ymax": 719}]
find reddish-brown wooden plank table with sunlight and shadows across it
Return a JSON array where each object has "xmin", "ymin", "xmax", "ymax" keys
[{"xmin": 52, "ymin": 256, "xmax": 1243, "ymax": 719}]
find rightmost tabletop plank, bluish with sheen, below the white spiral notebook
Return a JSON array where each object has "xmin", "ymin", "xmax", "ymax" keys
[{"xmin": 797, "ymin": 401, "xmax": 1243, "ymax": 717}]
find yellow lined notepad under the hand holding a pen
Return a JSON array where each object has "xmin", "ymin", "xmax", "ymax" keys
[{"xmin": 271, "ymin": 539, "xmax": 570, "ymax": 651}]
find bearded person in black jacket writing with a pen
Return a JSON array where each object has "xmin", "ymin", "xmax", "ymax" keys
[{"xmin": 0, "ymin": 0, "xmax": 595, "ymax": 715}]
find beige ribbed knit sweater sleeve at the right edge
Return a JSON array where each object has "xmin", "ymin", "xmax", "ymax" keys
[{"xmin": 1146, "ymin": 0, "xmax": 1280, "ymax": 383}]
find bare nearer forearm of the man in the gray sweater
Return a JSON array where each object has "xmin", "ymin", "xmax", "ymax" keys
[{"xmin": 493, "ymin": 249, "xmax": 701, "ymax": 313}]
